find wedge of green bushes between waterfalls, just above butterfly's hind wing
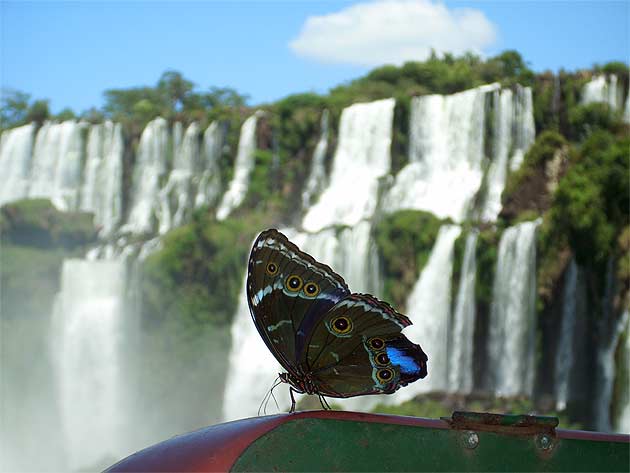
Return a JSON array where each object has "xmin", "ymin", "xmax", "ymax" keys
[{"xmin": 375, "ymin": 210, "xmax": 443, "ymax": 310}]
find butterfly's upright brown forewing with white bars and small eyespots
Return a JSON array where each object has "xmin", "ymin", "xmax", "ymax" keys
[{"xmin": 247, "ymin": 229, "xmax": 350, "ymax": 375}]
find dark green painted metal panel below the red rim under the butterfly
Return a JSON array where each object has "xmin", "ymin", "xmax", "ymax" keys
[{"xmin": 232, "ymin": 418, "xmax": 630, "ymax": 472}]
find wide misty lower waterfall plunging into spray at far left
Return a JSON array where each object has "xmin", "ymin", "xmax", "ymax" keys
[{"xmin": 51, "ymin": 259, "xmax": 135, "ymax": 470}]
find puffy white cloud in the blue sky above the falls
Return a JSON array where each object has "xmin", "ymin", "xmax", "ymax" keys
[{"xmin": 289, "ymin": 0, "xmax": 496, "ymax": 66}]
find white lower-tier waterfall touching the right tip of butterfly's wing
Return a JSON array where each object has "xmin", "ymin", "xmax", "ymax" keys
[{"xmin": 387, "ymin": 225, "xmax": 461, "ymax": 404}]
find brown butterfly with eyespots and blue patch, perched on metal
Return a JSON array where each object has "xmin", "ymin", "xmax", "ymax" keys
[{"xmin": 247, "ymin": 229, "xmax": 428, "ymax": 412}]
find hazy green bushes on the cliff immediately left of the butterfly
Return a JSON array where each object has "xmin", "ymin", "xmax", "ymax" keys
[{"xmin": 142, "ymin": 206, "xmax": 265, "ymax": 333}]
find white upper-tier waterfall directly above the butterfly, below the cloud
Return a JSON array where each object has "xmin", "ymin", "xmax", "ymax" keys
[{"xmin": 302, "ymin": 99, "xmax": 395, "ymax": 232}]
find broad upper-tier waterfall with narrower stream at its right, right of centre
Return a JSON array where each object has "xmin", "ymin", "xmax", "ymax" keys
[{"xmin": 383, "ymin": 84, "xmax": 535, "ymax": 221}]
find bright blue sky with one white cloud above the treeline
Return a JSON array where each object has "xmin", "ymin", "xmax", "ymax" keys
[{"xmin": 0, "ymin": 0, "xmax": 630, "ymax": 113}]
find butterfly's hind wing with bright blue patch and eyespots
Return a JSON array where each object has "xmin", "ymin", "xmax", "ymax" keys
[{"xmin": 301, "ymin": 294, "xmax": 427, "ymax": 397}]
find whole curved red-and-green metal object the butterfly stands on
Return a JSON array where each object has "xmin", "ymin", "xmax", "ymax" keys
[{"xmin": 107, "ymin": 411, "xmax": 630, "ymax": 472}]
